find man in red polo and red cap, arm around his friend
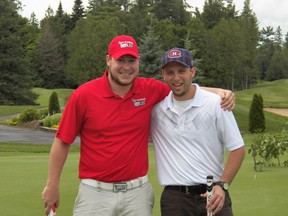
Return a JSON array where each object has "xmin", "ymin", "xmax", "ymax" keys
[{"xmin": 42, "ymin": 35, "xmax": 234, "ymax": 216}]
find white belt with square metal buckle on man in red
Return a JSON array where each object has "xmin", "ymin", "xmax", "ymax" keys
[{"xmin": 81, "ymin": 175, "xmax": 148, "ymax": 192}]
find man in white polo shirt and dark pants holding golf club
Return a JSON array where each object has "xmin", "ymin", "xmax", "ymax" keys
[{"xmin": 151, "ymin": 48, "xmax": 245, "ymax": 216}]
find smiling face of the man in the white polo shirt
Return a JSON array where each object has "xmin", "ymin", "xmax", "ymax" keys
[{"xmin": 162, "ymin": 62, "xmax": 195, "ymax": 100}]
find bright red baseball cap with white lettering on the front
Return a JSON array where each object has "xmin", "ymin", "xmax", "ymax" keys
[{"xmin": 108, "ymin": 35, "xmax": 139, "ymax": 60}]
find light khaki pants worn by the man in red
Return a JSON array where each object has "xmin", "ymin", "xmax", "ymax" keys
[{"xmin": 73, "ymin": 182, "xmax": 154, "ymax": 216}]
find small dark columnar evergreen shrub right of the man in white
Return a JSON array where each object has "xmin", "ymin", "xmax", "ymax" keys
[{"xmin": 249, "ymin": 94, "xmax": 265, "ymax": 133}]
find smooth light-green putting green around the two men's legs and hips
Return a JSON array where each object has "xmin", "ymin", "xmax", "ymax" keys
[{"xmin": 0, "ymin": 143, "xmax": 288, "ymax": 216}]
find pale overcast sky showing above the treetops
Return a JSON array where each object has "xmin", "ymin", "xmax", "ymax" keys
[{"xmin": 20, "ymin": 0, "xmax": 288, "ymax": 35}]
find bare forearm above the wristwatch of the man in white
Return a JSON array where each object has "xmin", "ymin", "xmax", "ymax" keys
[{"xmin": 220, "ymin": 147, "xmax": 245, "ymax": 183}]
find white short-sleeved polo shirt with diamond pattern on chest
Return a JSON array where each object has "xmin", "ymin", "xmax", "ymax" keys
[{"xmin": 151, "ymin": 84, "xmax": 244, "ymax": 186}]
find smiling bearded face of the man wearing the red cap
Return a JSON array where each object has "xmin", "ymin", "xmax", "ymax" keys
[{"xmin": 106, "ymin": 55, "xmax": 139, "ymax": 86}]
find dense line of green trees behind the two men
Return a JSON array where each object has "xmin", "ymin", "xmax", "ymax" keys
[{"xmin": 0, "ymin": 0, "xmax": 288, "ymax": 105}]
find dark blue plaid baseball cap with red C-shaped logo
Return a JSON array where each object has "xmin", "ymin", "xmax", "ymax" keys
[{"xmin": 162, "ymin": 47, "xmax": 193, "ymax": 68}]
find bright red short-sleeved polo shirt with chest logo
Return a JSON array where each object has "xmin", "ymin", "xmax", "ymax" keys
[{"xmin": 56, "ymin": 72, "xmax": 170, "ymax": 182}]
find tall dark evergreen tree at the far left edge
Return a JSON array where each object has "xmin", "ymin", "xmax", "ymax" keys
[{"xmin": 0, "ymin": 0, "xmax": 37, "ymax": 105}]
